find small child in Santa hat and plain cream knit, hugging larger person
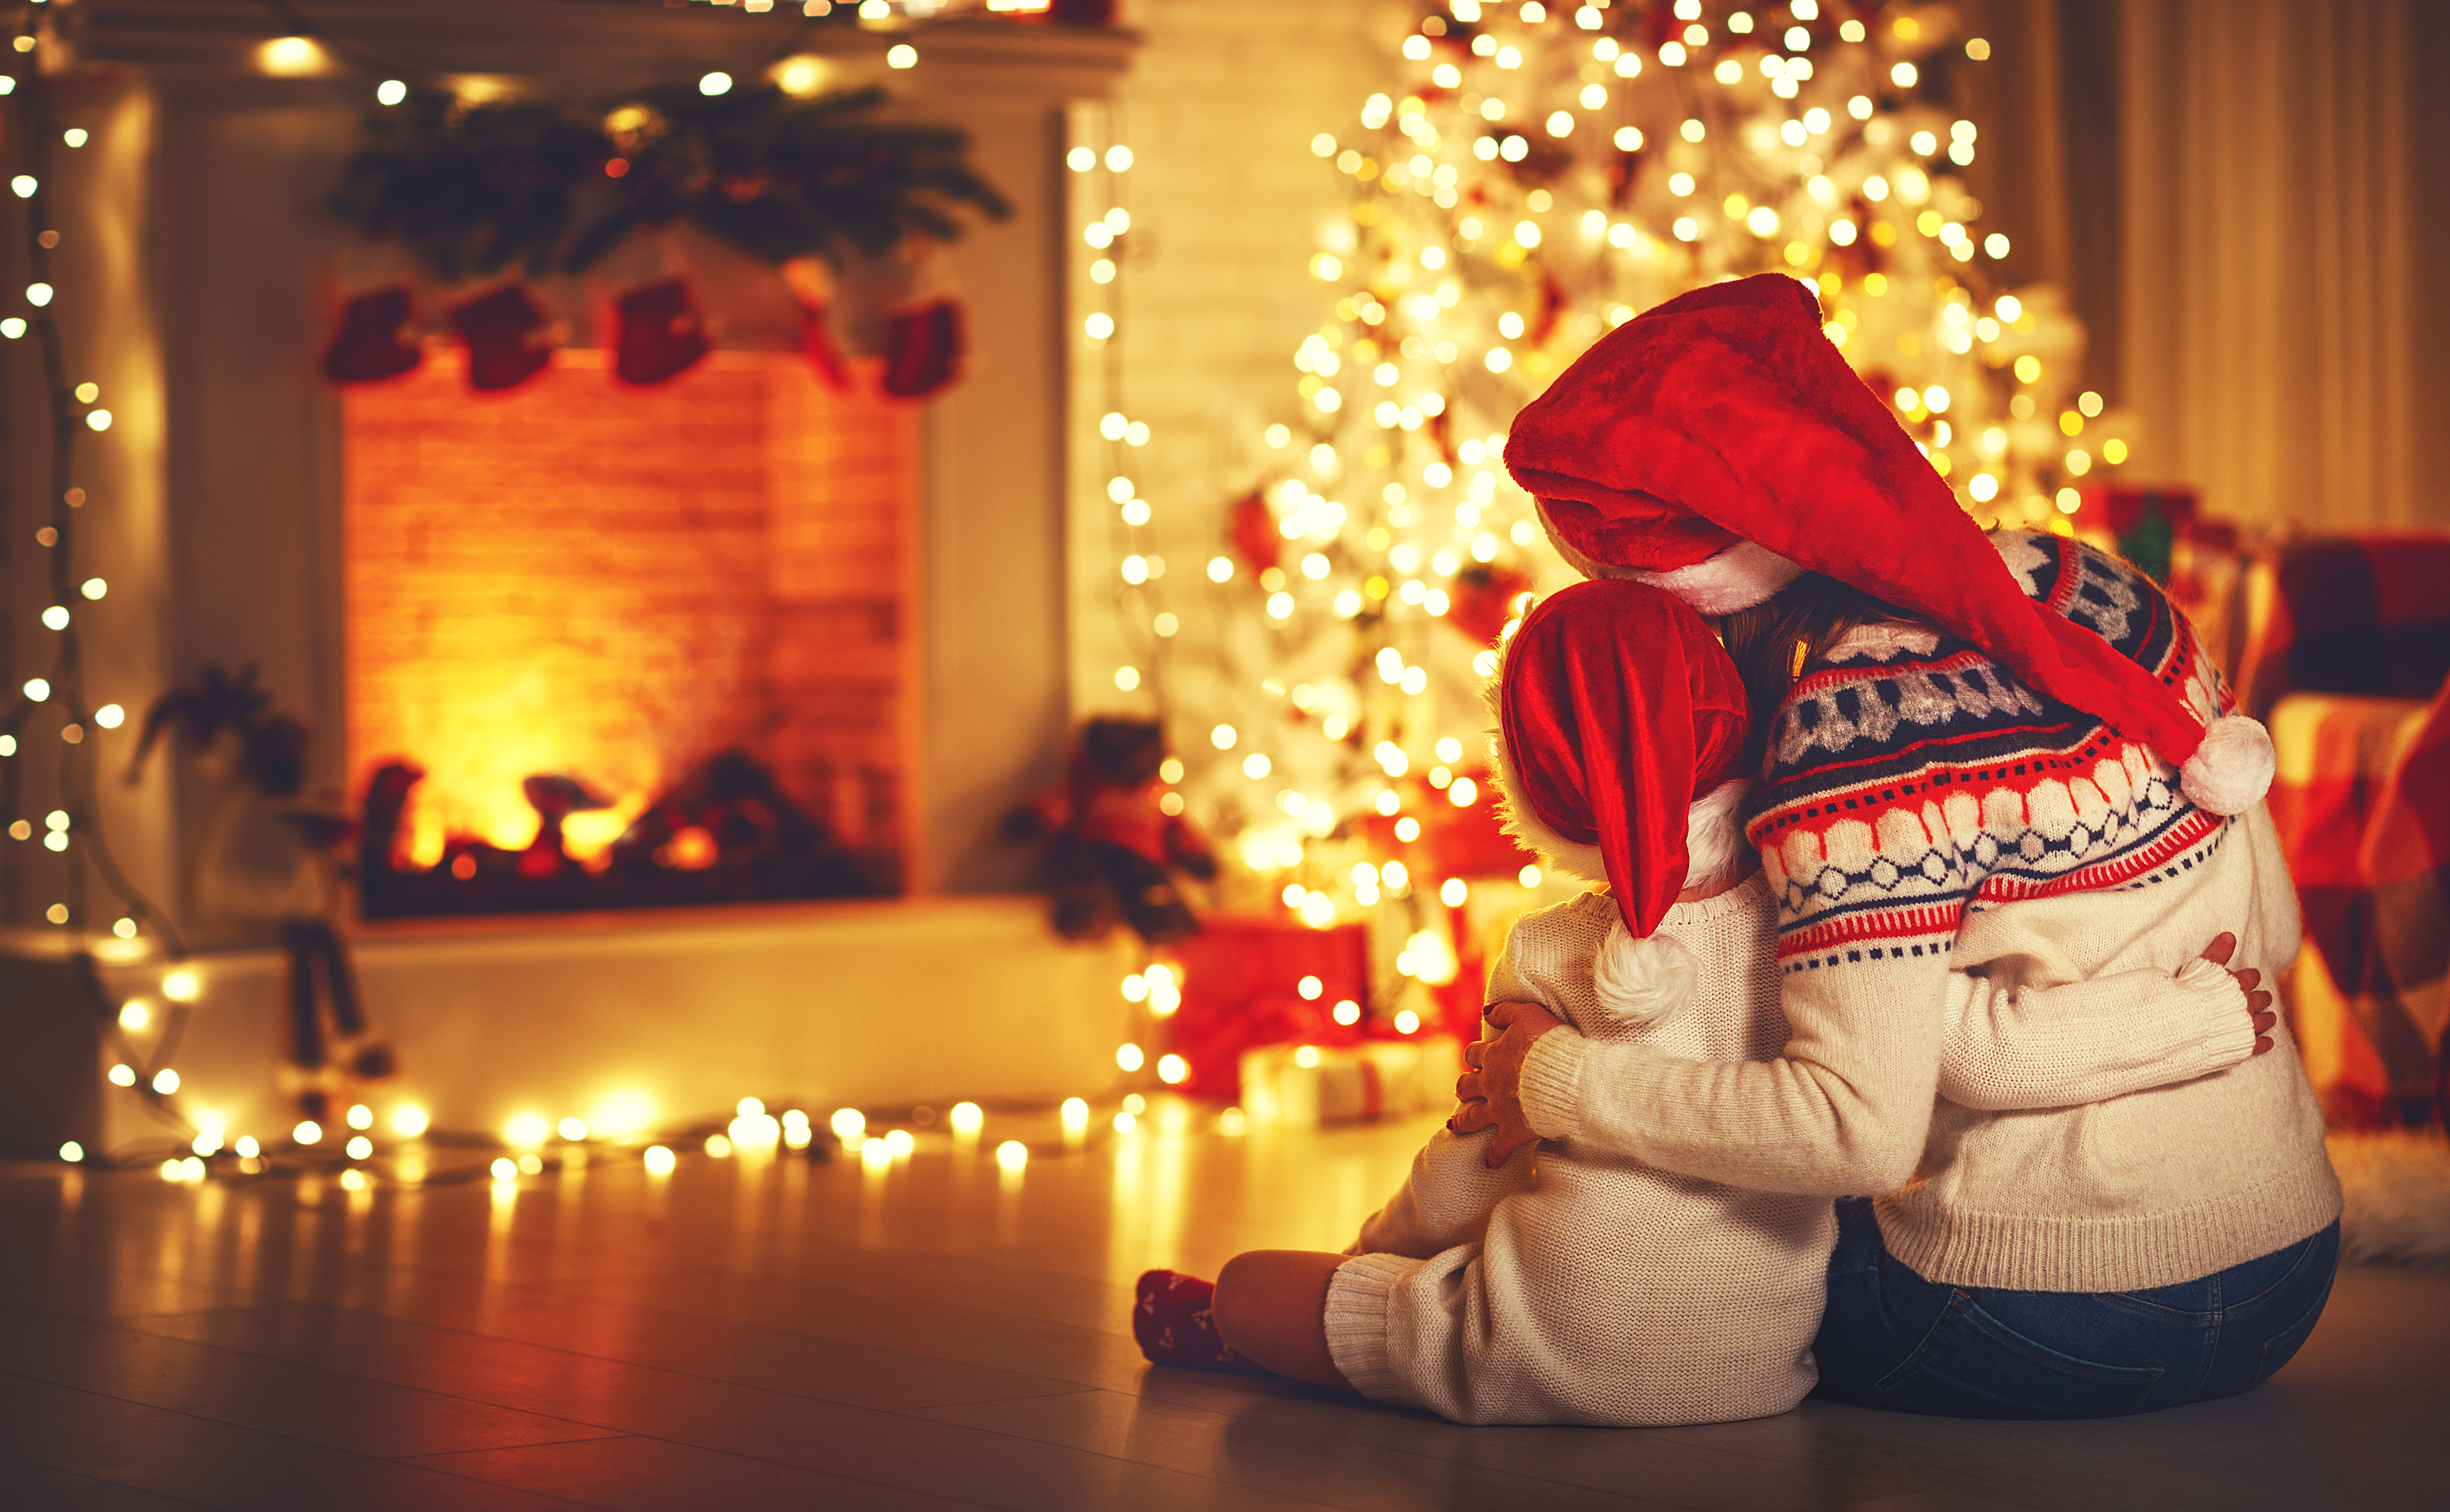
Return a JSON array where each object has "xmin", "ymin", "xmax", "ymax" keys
[{"xmin": 1134, "ymin": 571, "xmax": 2256, "ymax": 1424}]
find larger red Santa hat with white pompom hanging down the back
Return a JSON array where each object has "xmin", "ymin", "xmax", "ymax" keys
[{"xmin": 1507, "ymin": 272, "xmax": 2271, "ymax": 814}]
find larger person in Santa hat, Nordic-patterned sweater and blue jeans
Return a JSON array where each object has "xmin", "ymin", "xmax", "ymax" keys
[{"xmin": 1458, "ymin": 274, "xmax": 2340, "ymax": 1416}]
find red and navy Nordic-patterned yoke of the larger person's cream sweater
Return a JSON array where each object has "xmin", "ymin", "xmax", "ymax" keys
[{"xmin": 1747, "ymin": 532, "xmax": 2230, "ymax": 973}]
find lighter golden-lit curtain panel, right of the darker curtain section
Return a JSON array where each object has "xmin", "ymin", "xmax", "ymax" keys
[{"xmin": 2119, "ymin": 0, "xmax": 2450, "ymax": 529}]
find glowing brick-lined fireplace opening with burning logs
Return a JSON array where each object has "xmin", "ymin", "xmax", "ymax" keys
[{"xmin": 341, "ymin": 348, "xmax": 916, "ymax": 919}]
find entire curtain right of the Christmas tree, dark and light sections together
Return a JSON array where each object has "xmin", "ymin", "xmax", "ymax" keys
[{"xmin": 1962, "ymin": 0, "xmax": 2450, "ymax": 532}]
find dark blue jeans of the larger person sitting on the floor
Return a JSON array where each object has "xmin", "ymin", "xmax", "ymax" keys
[{"xmin": 1813, "ymin": 1198, "xmax": 2340, "ymax": 1419}]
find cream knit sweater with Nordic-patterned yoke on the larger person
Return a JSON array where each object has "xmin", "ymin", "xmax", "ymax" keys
[{"xmin": 1524, "ymin": 532, "xmax": 2340, "ymax": 1292}]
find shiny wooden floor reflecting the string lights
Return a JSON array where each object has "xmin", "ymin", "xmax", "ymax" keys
[{"xmin": 0, "ymin": 1108, "xmax": 2450, "ymax": 1512}]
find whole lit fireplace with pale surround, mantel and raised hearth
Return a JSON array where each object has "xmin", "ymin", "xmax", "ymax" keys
[{"xmin": 0, "ymin": 0, "xmax": 1132, "ymax": 1154}]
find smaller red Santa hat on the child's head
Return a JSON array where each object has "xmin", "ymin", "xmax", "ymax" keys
[{"xmin": 1490, "ymin": 581, "xmax": 1747, "ymax": 936}]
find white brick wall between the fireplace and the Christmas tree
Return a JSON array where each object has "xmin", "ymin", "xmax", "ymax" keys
[{"xmin": 1068, "ymin": 0, "xmax": 1414, "ymax": 742}]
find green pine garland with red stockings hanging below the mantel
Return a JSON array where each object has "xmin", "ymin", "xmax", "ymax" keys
[{"xmin": 323, "ymin": 73, "xmax": 1012, "ymax": 399}]
